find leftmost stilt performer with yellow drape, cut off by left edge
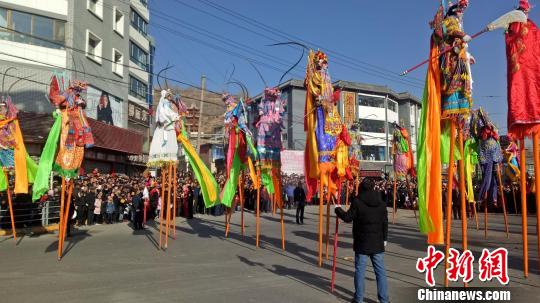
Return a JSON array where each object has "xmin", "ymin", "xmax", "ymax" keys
[{"xmin": 0, "ymin": 67, "xmax": 37, "ymax": 243}]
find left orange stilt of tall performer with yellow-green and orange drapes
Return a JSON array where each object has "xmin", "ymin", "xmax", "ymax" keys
[{"xmin": 444, "ymin": 121, "xmax": 456, "ymax": 287}]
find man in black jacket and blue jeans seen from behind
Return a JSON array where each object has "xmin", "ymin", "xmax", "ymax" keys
[{"xmin": 336, "ymin": 179, "xmax": 388, "ymax": 303}]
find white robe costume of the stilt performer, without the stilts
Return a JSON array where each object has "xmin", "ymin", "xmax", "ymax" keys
[{"xmin": 147, "ymin": 90, "xmax": 180, "ymax": 167}]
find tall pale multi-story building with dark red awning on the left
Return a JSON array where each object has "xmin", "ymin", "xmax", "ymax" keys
[{"xmin": 0, "ymin": 0, "xmax": 154, "ymax": 172}]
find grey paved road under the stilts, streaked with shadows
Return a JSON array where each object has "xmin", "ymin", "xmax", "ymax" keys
[{"xmin": 0, "ymin": 207, "xmax": 540, "ymax": 303}]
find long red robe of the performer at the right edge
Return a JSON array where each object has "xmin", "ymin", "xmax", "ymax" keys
[{"xmin": 506, "ymin": 1, "xmax": 540, "ymax": 138}]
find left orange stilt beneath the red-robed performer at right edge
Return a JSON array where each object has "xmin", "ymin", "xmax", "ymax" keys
[{"xmin": 519, "ymin": 138, "xmax": 529, "ymax": 278}]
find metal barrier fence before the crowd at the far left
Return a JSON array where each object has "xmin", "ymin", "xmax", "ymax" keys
[{"xmin": 0, "ymin": 200, "xmax": 60, "ymax": 229}]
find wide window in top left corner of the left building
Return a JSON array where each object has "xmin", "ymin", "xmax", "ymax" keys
[{"xmin": 0, "ymin": 8, "xmax": 66, "ymax": 49}]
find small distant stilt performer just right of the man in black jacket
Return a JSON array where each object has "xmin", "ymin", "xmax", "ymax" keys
[{"xmin": 392, "ymin": 123, "xmax": 416, "ymax": 223}]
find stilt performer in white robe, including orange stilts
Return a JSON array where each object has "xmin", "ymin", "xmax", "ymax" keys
[{"xmin": 146, "ymin": 66, "xmax": 180, "ymax": 249}]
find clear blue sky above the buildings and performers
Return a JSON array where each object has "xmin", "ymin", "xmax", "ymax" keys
[{"xmin": 149, "ymin": 0, "xmax": 540, "ymax": 133}]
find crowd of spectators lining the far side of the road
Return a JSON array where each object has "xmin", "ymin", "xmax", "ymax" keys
[{"xmin": 0, "ymin": 171, "xmax": 535, "ymax": 228}]
